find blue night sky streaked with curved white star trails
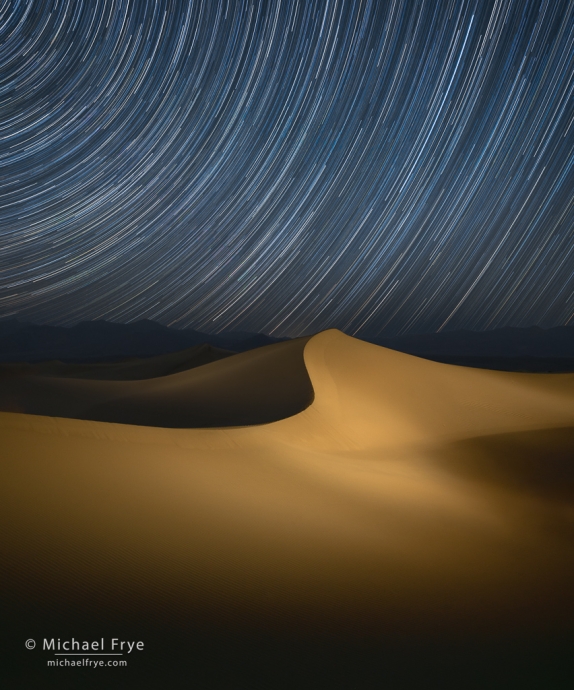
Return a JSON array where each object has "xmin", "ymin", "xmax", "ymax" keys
[{"xmin": 0, "ymin": 0, "xmax": 574, "ymax": 336}]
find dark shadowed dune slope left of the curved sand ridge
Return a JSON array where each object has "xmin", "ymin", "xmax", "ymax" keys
[{"xmin": 0, "ymin": 338, "xmax": 313, "ymax": 428}]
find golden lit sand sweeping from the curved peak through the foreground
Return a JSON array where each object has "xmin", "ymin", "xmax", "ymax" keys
[{"xmin": 0, "ymin": 330, "xmax": 574, "ymax": 687}]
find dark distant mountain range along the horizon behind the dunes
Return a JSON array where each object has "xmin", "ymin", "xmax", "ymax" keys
[{"xmin": 0, "ymin": 319, "xmax": 574, "ymax": 371}]
